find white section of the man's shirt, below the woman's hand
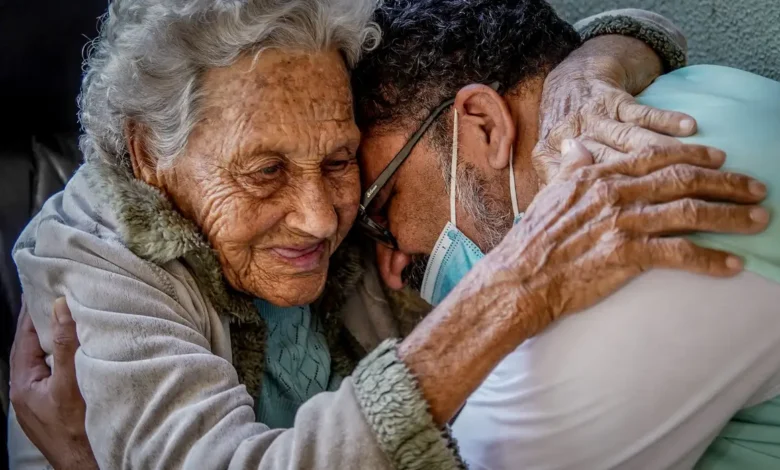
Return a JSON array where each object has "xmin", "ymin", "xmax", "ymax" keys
[{"xmin": 453, "ymin": 270, "xmax": 780, "ymax": 470}]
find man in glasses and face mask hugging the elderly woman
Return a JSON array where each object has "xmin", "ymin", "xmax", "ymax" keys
[{"xmin": 353, "ymin": 0, "xmax": 780, "ymax": 469}]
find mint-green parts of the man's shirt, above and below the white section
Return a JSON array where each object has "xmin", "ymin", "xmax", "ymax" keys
[{"xmin": 639, "ymin": 65, "xmax": 780, "ymax": 470}]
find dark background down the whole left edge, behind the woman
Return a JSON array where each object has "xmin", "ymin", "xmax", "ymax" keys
[{"xmin": 0, "ymin": 0, "xmax": 108, "ymax": 469}]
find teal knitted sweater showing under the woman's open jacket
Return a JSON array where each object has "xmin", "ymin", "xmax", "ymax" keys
[{"xmin": 255, "ymin": 300, "xmax": 332, "ymax": 429}]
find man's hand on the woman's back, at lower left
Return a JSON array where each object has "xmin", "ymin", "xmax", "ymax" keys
[{"xmin": 11, "ymin": 298, "xmax": 98, "ymax": 470}]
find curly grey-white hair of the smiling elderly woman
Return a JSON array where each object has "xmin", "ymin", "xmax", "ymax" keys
[{"xmin": 79, "ymin": 0, "xmax": 380, "ymax": 168}]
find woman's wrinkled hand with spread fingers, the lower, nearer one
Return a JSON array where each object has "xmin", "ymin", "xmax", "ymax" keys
[{"xmin": 470, "ymin": 140, "xmax": 769, "ymax": 339}]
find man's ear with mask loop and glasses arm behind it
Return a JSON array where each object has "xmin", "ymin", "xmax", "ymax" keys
[{"xmin": 455, "ymin": 84, "xmax": 516, "ymax": 170}]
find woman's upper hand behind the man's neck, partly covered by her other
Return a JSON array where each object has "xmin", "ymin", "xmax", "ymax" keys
[{"xmin": 532, "ymin": 39, "xmax": 696, "ymax": 183}]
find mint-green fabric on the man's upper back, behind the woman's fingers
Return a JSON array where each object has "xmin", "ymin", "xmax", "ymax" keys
[{"xmin": 639, "ymin": 65, "xmax": 780, "ymax": 282}]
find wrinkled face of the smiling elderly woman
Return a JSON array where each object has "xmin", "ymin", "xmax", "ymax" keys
[{"xmin": 158, "ymin": 50, "xmax": 360, "ymax": 306}]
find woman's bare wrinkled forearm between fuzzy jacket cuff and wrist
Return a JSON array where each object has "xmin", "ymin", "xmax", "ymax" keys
[{"xmin": 399, "ymin": 263, "xmax": 540, "ymax": 425}]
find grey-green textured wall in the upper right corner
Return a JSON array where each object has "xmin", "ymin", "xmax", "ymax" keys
[{"xmin": 548, "ymin": 0, "xmax": 780, "ymax": 80}]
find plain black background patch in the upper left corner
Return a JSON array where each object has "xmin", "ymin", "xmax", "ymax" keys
[{"xmin": 0, "ymin": 0, "xmax": 107, "ymax": 136}]
